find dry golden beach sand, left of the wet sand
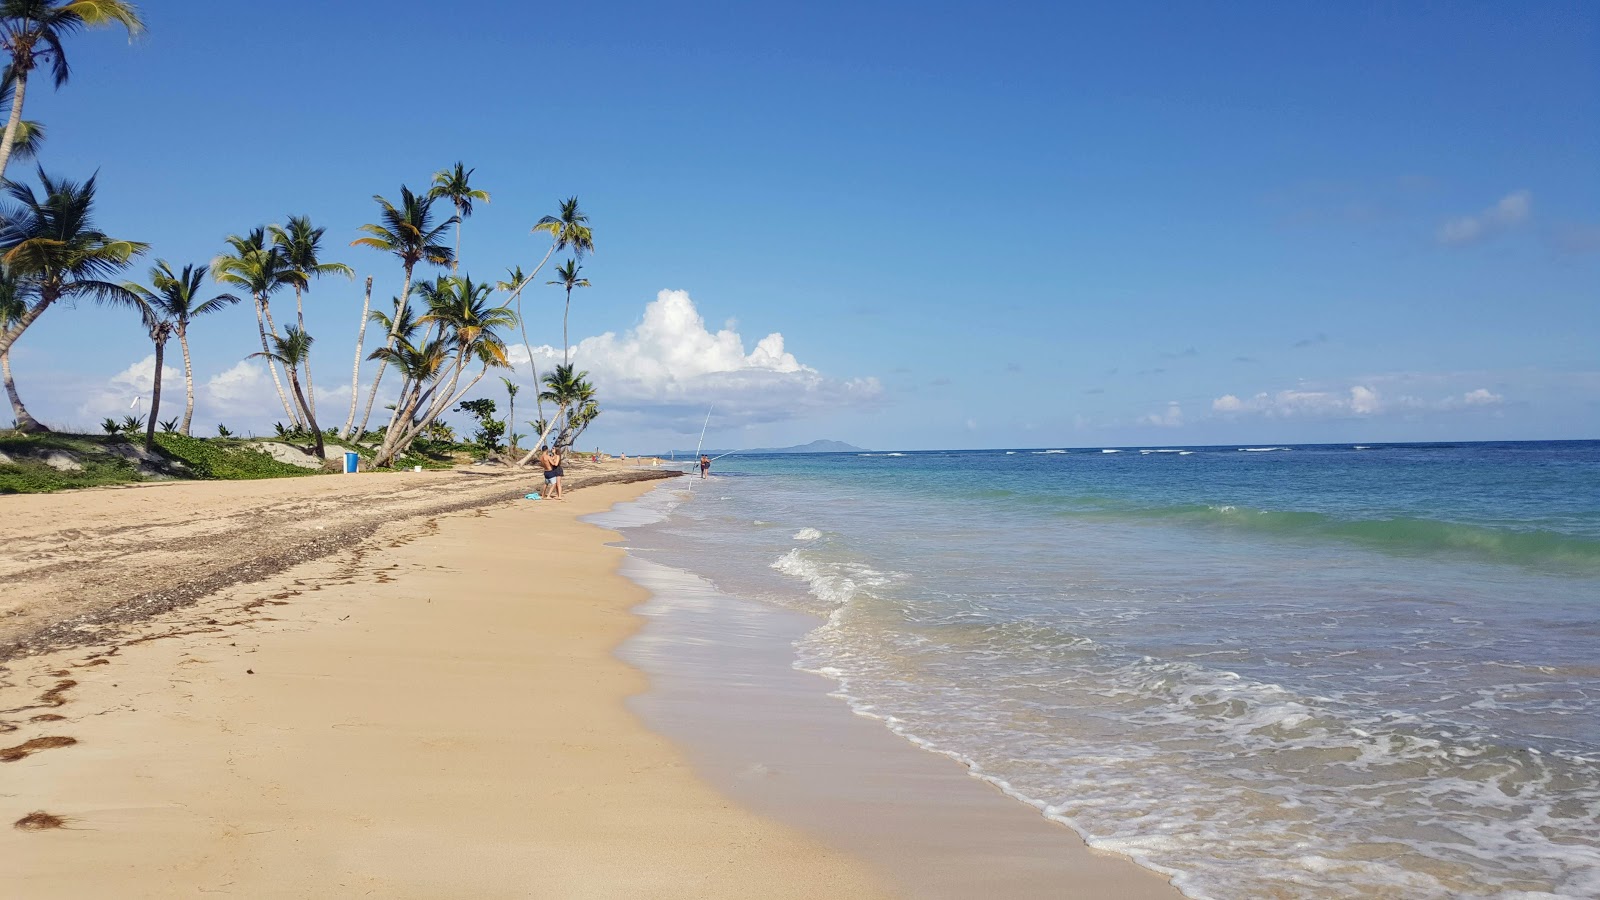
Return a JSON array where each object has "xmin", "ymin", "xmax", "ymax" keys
[{"xmin": 0, "ymin": 476, "xmax": 882, "ymax": 898}]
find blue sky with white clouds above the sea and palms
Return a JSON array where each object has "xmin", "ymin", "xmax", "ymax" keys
[{"xmin": 10, "ymin": 0, "xmax": 1600, "ymax": 450}]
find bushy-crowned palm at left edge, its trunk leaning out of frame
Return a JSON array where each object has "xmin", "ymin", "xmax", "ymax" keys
[{"xmin": 0, "ymin": 170, "xmax": 149, "ymax": 361}]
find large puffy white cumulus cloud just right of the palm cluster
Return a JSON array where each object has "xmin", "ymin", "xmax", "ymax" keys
[{"xmin": 510, "ymin": 290, "xmax": 883, "ymax": 424}]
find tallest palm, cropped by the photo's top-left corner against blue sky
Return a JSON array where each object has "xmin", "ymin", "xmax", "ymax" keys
[{"xmin": 0, "ymin": 0, "xmax": 144, "ymax": 178}]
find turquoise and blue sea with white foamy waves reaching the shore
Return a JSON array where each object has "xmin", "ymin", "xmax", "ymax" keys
[{"xmin": 611, "ymin": 442, "xmax": 1600, "ymax": 898}]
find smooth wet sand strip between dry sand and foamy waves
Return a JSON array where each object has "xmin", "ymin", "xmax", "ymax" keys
[{"xmin": 604, "ymin": 484, "xmax": 1184, "ymax": 900}]
